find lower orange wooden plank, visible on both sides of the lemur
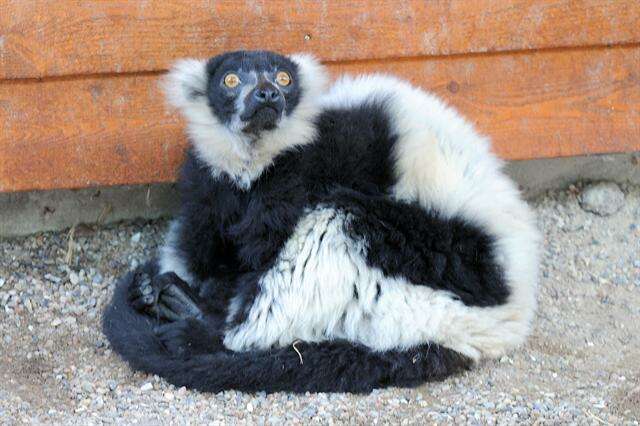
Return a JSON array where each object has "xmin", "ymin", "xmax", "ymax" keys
[{"xmin": 0, "ymin": 47, "xmax": 640, "ymax": 191}]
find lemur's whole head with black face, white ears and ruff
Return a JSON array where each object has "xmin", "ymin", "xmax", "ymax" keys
[{"xmin": 165, "ymin": 51, "xmax": 327, "ymax": 187}]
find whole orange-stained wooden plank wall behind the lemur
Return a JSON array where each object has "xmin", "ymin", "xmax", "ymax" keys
[{"xmin": 0, "ymin": 0, "xmax": 640, "ymax": 192}]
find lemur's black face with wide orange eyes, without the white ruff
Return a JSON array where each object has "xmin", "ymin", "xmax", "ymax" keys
[{"xmin": 206, "ymin": 51, "xmax": 300, "ymax": 136}]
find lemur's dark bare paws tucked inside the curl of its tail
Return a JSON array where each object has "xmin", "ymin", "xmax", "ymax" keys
[{"xmin": 129, "ymin": 271, "xmax": 203, "ymax": 322}]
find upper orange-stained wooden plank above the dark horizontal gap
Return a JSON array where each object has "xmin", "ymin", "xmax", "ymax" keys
[{"xmin": 0, "ymin": 0, "xmax": 640, "ymax": 79}]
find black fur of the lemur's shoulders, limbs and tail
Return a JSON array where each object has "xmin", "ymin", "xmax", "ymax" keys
[{"xmin": 104, "ymin": 55, "xmax": 509, "ymax": 392}]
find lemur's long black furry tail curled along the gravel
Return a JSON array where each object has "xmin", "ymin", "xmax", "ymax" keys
[{"xmin": 103, "ymin": 264, "xmax": 472, "ymax": 393}]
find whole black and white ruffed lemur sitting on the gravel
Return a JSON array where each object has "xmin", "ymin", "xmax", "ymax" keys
[{"xmin": 103, "ymin": 51, "xmax": 539, "ymax": 392}]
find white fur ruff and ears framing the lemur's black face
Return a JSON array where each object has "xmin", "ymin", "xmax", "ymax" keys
[{"xmin": 163, "ymin": 54, "xmax": 327, "ymax": 190}]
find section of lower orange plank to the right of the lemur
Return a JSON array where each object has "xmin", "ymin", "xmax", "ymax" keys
[{"xmin": 335, "ymin": 47, "xmax": 640, "ymax": 160}]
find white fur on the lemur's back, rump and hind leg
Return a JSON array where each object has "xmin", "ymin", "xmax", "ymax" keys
[{"xmin": 224, "ymin": 71, "xmax": 540, "ymax": 360}]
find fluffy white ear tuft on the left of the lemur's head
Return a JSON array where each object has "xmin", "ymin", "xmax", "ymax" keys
[{"xmin": 162, "ymin": 59, "xmax": 208, "ymax": 110}]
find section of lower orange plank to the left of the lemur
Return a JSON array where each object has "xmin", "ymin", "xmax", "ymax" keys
[{"xmin": 0, "ymin": 75, "xmax": 184, "ymax": 192}]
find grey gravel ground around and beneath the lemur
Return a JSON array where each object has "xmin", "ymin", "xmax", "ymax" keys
[{"xmin": 0, "ymin": 185, "xmax": 640, "ymax": 425}]
